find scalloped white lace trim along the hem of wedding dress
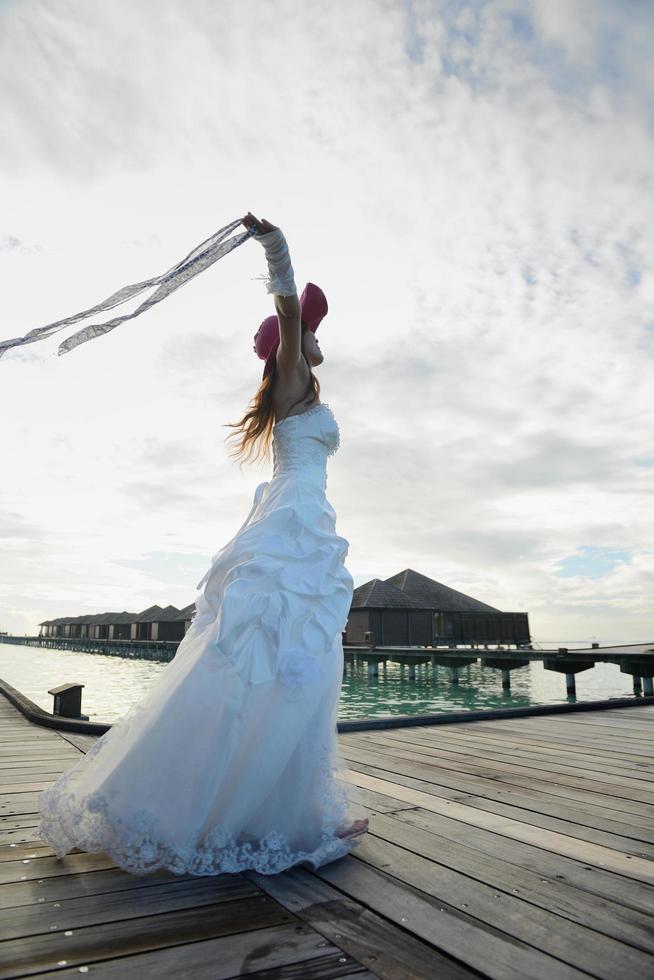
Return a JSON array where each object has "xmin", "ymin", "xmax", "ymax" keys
[{"xmin": 38, "ymin": 704, "xmax": 361, "ymax": 875}]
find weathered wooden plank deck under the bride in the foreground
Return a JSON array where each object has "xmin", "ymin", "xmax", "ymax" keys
[{"xmin": 0, "ymin": 697, "xmax": 654, "ymax": 980}]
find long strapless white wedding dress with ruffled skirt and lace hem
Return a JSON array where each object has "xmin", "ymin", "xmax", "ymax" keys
[{"xmin": 39, "ymin": 402, "xmax": 365, "ymax": 875}]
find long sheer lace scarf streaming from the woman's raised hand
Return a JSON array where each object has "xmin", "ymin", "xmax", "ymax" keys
[{"xmin": 0, "ymin": 218, "xmax": 256, "ymax": 357}]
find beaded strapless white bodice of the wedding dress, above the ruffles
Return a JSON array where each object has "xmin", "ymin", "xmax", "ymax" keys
[{"xmin": 273, "ymin": 402, "xmax": 340, "ymax": 489}]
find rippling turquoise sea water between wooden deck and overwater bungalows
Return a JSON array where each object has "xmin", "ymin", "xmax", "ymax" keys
[{"xmin": 0, "ymin": 643, "xmax": 634, "ymax": 723}]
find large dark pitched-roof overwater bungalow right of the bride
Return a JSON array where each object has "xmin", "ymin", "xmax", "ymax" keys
[{"xmin": 344, "ymin": 568, "xmax": 530, "ymax": 646}]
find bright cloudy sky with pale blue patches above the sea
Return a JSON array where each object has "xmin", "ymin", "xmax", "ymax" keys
[{"xmin": 0, "ymin": 0, "xmax": 654, "ymax": 646}]
